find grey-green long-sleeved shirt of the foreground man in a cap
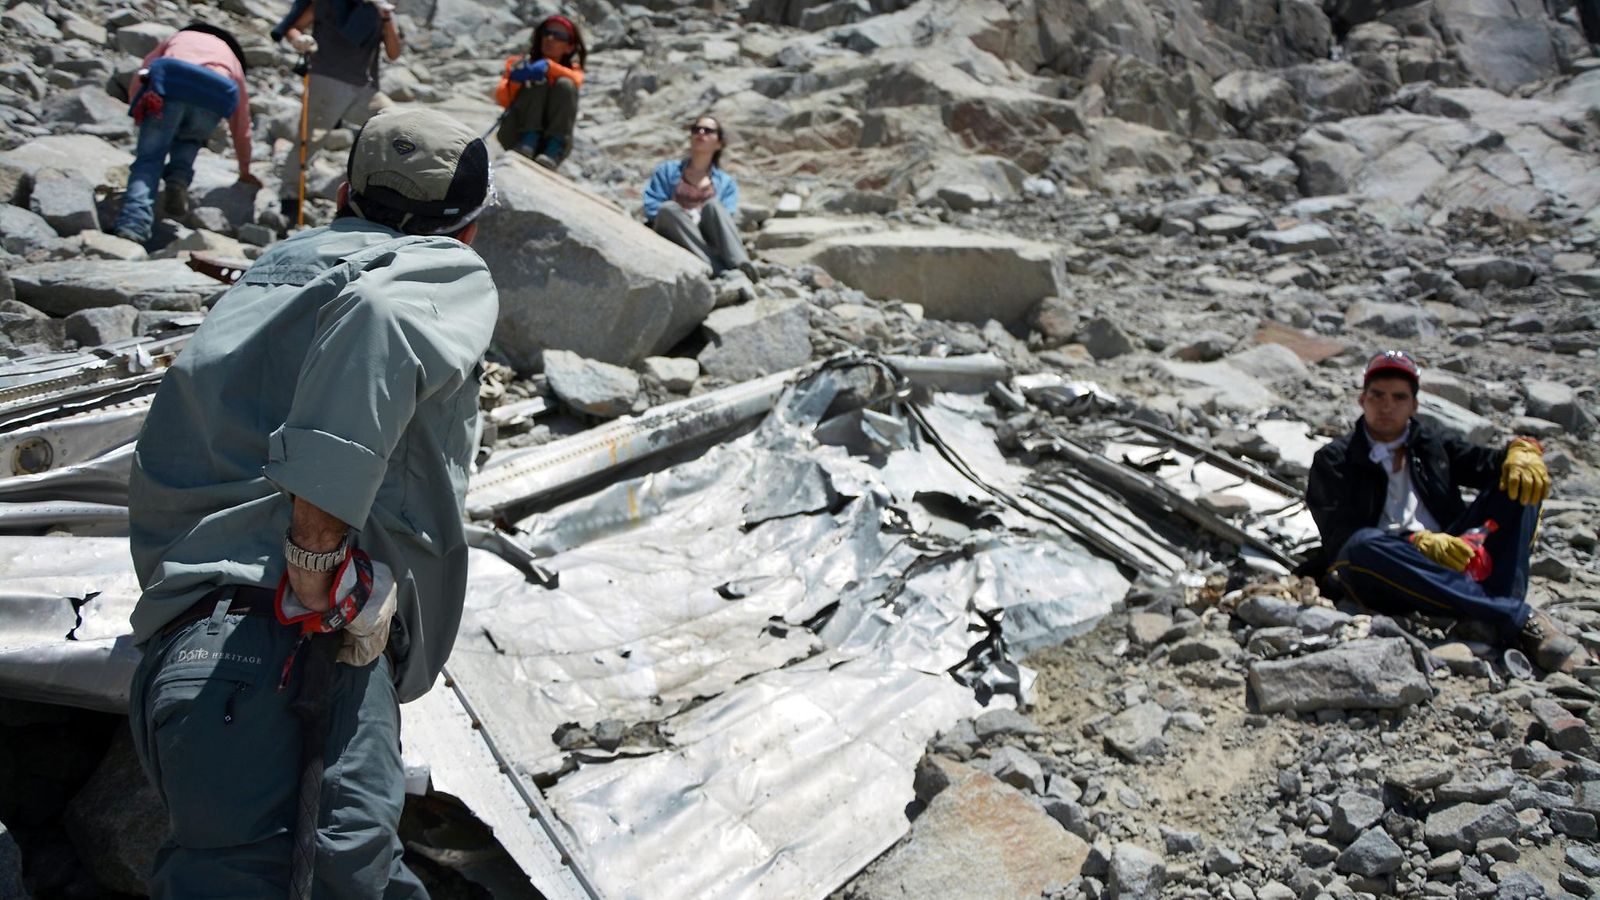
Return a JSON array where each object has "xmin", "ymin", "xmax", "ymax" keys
[{"xmin": 128, "ymin": 218, "xmax": 499, "ymax": 701}]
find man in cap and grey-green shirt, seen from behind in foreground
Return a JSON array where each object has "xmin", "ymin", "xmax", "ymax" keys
[{"xmin": 130, "ymin": 110, "xmax": 499, "ymax": 898}]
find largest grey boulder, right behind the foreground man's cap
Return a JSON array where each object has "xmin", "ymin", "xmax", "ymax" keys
[{"xmin": 472, "ymin": 154, "xmax": 717, "ymax": 368}]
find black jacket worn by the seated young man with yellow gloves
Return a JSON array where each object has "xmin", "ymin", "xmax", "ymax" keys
[{"xmin": 1296, "ymin": 420, "xmax": 1506, "ymax": 578}]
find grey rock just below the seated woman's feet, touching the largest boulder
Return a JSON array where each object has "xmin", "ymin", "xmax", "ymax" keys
[{"xmin": 699, "ymin": 299, "xmax": 811, "ymax": 381}]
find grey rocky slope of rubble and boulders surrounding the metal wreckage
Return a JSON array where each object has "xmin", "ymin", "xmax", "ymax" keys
[{"xmin": 0, "ymin": 0, "xmax": 1600, "ymax": 900}]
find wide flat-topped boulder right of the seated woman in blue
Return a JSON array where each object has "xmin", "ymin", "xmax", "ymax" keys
[{"xmin": 771, "ymin": 227, "xmax": 1066, "ymax": 322}]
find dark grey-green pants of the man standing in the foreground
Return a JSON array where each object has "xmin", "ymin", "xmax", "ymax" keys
[{"xmin": 128, "ymin": 595, "xmax": 427, "ymax": 900}]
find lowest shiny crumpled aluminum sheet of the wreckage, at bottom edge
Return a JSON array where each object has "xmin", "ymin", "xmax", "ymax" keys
[{"xmin": 547, "ymin": 653, "xmax": 981, "ymax": 900}]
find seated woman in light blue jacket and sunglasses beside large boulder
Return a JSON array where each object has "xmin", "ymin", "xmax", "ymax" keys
[{"xmin": 645, "ymin": 115, "xmax": 757, "ymax": 280}]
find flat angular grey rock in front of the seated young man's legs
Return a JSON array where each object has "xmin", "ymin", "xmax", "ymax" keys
[{"xmin": 1250, "ymin": 637, "xmax": 1434, "ymax": 713}]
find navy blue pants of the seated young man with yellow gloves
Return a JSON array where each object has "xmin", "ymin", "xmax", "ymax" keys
[{"xmin": 1328, "ymin": 488, "xmax": 1539, "ymax": 641}]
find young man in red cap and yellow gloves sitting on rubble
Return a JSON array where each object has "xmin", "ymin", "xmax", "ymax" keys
[{"xmin": 1301, "ymin": 351, "xmax": 1586, "ymax": 671}]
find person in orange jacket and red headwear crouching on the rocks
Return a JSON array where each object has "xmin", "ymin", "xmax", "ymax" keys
[{"xmin": 494, "ymin": 16, "xmax": 589, "ymax": 168}]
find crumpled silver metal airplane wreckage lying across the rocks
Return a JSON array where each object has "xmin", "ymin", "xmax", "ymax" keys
[{"xmin": 0, "ymin": 304, "xmax": 1315, "ymax": 900}]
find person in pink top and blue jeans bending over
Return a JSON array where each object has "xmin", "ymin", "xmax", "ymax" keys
[{"xmin": 112, "ymin": 22, "xmax": 261, "ymax": 243}]
